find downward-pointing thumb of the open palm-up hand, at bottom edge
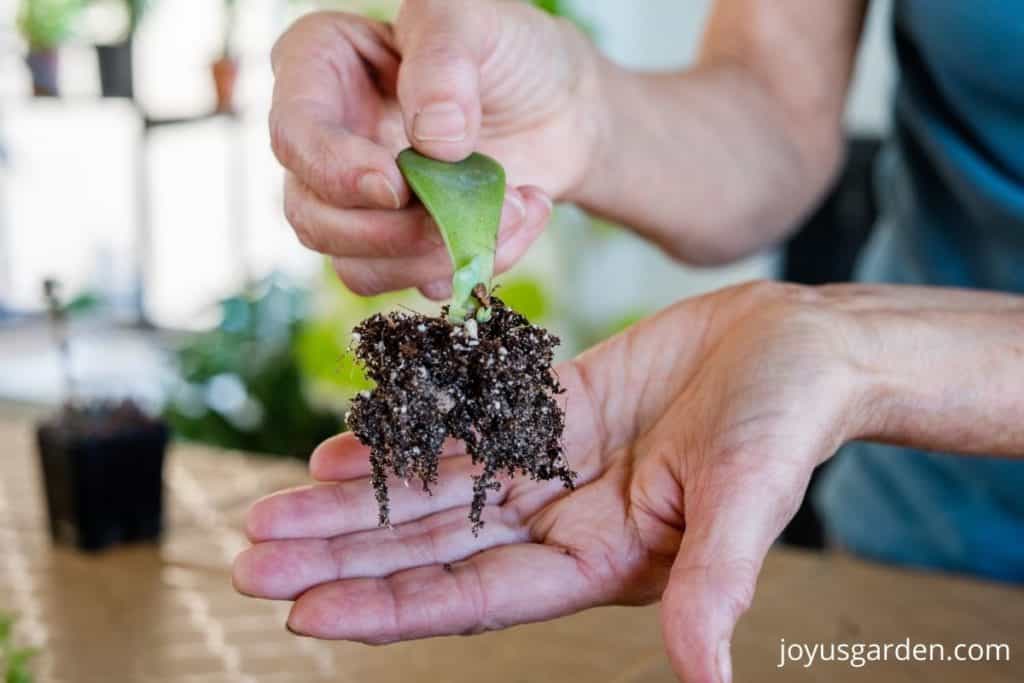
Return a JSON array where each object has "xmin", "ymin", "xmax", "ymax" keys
[{"xmin": 662, "ymin": 461, "xmax": 810, "ymax": 683}]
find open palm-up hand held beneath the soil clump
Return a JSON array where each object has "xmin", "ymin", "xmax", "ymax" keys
[{"xmin": 234, "ymin": 284, "xmax": 880, "ymax": 682}]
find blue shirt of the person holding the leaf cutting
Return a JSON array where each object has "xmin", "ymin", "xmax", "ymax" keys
[{"xmin": 817, "ymin": 0, "xmax": 1024, "ymax": 582}]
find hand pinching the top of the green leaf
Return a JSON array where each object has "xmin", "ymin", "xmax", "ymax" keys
[{"xmin": 270, "ymin": 0, "xmax": 601, "ymax": 299}]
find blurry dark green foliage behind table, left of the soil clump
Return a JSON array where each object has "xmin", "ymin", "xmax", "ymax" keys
[{"xmin": 165, "ymin": 278, "xmax": 341, "ymax": 458}]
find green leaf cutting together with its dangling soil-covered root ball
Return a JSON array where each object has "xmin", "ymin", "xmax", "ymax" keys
[{"xmin": 346, "ymin": 150, "xmax": 575, "ymax": 533}]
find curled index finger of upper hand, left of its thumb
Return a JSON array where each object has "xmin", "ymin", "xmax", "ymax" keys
[{"xmin": 270, "ymin": 12, "xmax": 410, "ymax": 209}]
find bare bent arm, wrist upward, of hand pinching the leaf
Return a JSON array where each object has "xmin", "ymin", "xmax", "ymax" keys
[{"xmin": 570, "ymin": 0, "xmax": 863, "ymax": 263}]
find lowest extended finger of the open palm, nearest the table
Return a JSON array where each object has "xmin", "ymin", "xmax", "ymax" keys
[{"xmin": 288, "ymin": 544, "xmax": 601, "ymax": 644}]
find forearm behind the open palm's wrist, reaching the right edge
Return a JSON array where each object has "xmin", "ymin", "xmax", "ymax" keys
[{"xmin": 833, "ymin": 287, "xmax": 1024, "ymax": 456}]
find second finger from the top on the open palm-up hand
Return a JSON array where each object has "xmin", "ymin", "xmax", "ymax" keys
[{"xmin": 246, "ymin": 456, "xmax": 505, "ymax": 542}]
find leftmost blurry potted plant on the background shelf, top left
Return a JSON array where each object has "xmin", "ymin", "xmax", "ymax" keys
[{"xmin": 17, "ymin": 0, "xmax": 82, "ymax": 97}]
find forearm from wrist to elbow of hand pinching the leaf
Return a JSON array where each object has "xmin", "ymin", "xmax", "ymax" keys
[{"xmin": 571, "ymin": 65, "xmax": 839, "ymax": 264}]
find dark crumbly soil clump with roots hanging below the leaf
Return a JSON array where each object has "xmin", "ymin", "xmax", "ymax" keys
[{"xmin": 347, "ymin": 297, "xmax": 575, "ymax": 533}]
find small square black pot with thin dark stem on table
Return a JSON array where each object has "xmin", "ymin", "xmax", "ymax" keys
[{"xmin": 36, "ymin": 281, "xmax": 168, "ymax": 551}]
